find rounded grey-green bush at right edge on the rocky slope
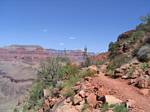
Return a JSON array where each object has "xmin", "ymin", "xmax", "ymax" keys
[{"xmin": 137, "ymin": 44, "xmax": 150, "ymax": 62}]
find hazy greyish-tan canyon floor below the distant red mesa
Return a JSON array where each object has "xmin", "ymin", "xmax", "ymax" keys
[{"xmin": 0, "ymin": 61, "xmax": 36, "ymax": 112}]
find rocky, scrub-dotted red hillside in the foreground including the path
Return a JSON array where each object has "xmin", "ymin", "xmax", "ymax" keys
[{"xmin": 15, "ymin": 15, "xmax": 150, "ymax": 112}]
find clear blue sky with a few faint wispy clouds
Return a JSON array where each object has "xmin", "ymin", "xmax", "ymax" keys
[{"xmin": 0, "ymin": 0, "xmax": 150, "ymax": 53}]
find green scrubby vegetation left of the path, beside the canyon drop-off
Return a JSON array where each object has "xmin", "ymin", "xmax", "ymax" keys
[{"xmin": 15, "ymin": 57, "xmax": 94, "ymax": 112}]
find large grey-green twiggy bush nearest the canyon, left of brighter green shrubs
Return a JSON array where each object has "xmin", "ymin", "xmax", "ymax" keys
[{"xmin": 38, "ymin": 57, "xmax": 67, "ymax": 86}]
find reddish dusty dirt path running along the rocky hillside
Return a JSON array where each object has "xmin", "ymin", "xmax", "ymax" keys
[{"xmin": 95, "ymin": 73, "xmax": 150, "ymax": 112}]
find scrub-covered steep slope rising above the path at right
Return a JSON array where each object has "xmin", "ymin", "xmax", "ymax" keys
[{"xmin": 107, "ymin": 15, "xmax": 150, "ymax": 75}]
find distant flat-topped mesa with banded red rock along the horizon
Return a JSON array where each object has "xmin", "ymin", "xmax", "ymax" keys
[{"xmin": 0, "ymin": 45, "xmax": 94, "ymax": 62}]
